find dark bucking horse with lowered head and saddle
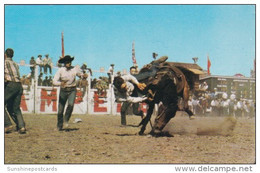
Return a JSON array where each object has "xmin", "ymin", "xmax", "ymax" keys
[{"xmin": 135, "ymin": 56, "xmax": 198, "ymax": 136}]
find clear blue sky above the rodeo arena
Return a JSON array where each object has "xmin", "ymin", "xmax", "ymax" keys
[{"xmin": 4, "ymin": 5, "xmax": 256, "ymax": 77}]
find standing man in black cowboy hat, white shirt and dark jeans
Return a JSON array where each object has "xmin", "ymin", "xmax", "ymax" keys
[{"xmin": 53, "ymin": 55, "xmax": 87, "ymax": 131}]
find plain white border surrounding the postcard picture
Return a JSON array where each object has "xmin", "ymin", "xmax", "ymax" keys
[{"xmin": 0, "ymin": 0, "xmax": 260, "ymax": 173}]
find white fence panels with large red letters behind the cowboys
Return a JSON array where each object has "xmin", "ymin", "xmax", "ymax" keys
[{"xmin": 20, "ymin": 87, "xmax": 146, "ymax": 115}]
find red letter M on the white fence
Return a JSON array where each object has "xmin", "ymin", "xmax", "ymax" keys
[{"xmin": 40, "ymin": 88, "xmax": 57, "ymax": 112}]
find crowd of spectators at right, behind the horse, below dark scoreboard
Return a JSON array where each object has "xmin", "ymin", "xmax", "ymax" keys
[{"xmin": 188, "ymin": 82, "xmax": 255, "ymax": 118}]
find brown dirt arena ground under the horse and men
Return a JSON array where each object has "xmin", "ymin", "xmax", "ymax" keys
[{"xmin": 5, "ymin": 112, "xmax": 256, "ymax": 164}]
